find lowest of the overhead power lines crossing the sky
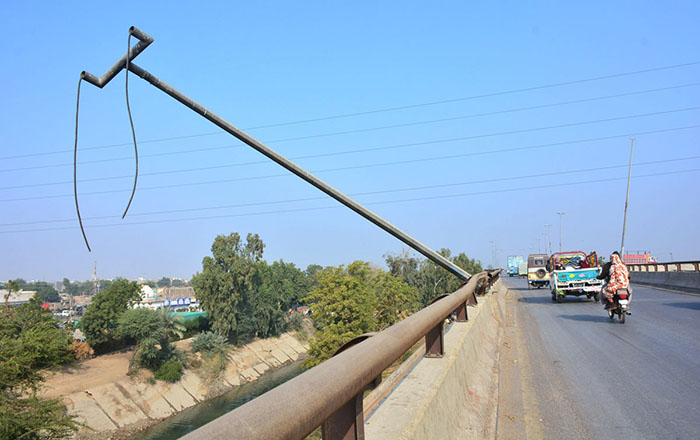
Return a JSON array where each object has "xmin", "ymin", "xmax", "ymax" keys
[{"xmin": 0, "ymin": 168, "xmax": 700, "ymax": 234}]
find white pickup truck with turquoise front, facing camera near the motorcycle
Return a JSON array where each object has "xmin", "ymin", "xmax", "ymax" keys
[{"xmin": 547, "ymin": 251, "xmax": 603, "ymax": 302}]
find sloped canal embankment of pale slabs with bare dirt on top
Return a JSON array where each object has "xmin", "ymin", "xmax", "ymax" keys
[{"xmin": 45, "ymin": 333, "xmax": 308, "ymax": 440}]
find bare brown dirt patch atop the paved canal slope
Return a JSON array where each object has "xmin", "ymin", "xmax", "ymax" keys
[{"xmin": 44, "ymin": 339, "xmax": 191, "ymax": 398}]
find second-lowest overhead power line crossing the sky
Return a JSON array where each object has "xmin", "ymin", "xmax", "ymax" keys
[{"xmin": 0, "ymin": 156, "xmax": 700, "ymax": 227}]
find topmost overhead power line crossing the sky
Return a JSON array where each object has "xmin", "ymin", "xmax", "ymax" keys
[{"xmin": 0, "ymin": 61, "xmax": 700, "ymax": 160}]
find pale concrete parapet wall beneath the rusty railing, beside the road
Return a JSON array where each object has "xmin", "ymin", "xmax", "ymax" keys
[{"xmin": 365, "ymin": 281, "xmax": 505, "ymax": 440}]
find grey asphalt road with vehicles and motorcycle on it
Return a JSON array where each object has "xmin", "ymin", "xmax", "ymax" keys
[{"xmin": 499, "ymin": 276, "xmax": 700, "ymax": 439}]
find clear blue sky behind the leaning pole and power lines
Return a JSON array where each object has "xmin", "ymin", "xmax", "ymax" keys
[{"xmin": 0, "ymin": 1, "xmax": 700, "ymax": 280}]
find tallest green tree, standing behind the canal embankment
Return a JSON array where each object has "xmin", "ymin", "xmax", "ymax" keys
[{"xmin": 192, "ymin": 232, "xmax": 265, "ymax": 342}]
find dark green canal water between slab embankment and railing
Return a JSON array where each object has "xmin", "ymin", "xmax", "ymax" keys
[{"xmin": 130, "ymin": 361, "xmax": 302, "ymax": 440}]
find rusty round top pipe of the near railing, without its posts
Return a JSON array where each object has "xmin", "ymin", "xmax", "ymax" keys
[{"xmin": 183, "ymin": 272, "xmax": 488, "ymax": 440}]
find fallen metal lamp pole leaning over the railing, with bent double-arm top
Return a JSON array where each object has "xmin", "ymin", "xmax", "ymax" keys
[{"xmin": 81, "ymin": 26, "xmax": 471, "ymax": 281}]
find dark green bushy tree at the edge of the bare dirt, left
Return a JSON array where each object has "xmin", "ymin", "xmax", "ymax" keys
[{"xmin": 80, "ymin": 280, "xmax": 141, "ymax": 352}]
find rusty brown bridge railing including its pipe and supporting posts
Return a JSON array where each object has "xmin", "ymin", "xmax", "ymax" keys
[{"xmin": 183, "ymin": 269, "xmax": 500, "ymax": 440}]
